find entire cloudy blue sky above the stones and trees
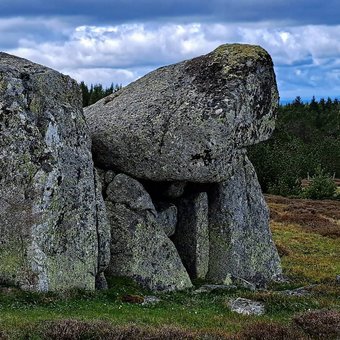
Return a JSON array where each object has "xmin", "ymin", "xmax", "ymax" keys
[{"xmin": 0, "ymin": 0, "xmax": 340, "ymax": 100}]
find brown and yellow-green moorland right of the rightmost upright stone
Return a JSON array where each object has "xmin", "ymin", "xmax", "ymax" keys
[{"xmin": 266, "ymin": 195, "xmax": 340, "ymax": 285}]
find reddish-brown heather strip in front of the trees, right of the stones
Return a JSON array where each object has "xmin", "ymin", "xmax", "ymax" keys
[{"xmin": 266, "ymin": 195, "xmax": 340, "ymax": 238}]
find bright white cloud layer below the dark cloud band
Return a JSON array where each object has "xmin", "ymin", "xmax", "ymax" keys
[{"xmin": 4, "ymin": 22, "xmax": 340, "ymax": 98}]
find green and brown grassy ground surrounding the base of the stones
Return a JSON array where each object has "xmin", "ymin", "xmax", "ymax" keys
[{"xmin": 0, "ymin": 196, "xmax": 340, "ymax": 339}]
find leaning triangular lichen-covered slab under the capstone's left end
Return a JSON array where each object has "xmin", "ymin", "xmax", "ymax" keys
[{"xmin": 106, "ymin": 174, "xmax": 192, "ymax": 291}]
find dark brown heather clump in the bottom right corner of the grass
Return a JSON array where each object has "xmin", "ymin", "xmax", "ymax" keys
[{"xmin": 294, "ymin": 310, "xmax": 340, "ymax": 339}]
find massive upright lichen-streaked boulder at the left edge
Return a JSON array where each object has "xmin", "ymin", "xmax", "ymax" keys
[{"xmin": 0, "ymin": 53, "xmax": 109, "ymax": 291}]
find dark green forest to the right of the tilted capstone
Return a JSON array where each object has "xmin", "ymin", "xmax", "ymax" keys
[{"xmin": 248, "ymin": 97, "xmax": 340, "ymax": 196}]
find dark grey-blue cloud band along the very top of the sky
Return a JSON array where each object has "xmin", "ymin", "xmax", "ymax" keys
[{"xmin": 0, "ymin": 0, "xmax": 340, "ymax": 25}]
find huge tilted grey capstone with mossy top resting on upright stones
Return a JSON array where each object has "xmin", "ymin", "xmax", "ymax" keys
[{"xmin": 85, "ymin": 44, "xmax": 278, "ymax": 183}]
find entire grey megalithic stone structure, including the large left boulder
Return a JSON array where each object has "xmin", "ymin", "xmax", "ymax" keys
[{"xmin": 0, "ymin": 44, "xmax": 281, "ymax": 291}]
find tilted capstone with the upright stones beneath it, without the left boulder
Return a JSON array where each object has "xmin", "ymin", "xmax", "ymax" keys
[{"xmin": 85, "ymin": 44, "xmax": 281, "ymax": 288}]
